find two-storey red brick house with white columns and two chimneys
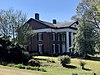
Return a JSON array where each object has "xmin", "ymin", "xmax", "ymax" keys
[{"xmin": 23, "ymin": 13, "xmax": 78, "ymax": 55}]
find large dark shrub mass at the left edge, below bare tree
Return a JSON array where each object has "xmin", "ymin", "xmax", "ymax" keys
[{"xmin": 0, "ymin": 36, "xmax": 32, "ymax": 65}]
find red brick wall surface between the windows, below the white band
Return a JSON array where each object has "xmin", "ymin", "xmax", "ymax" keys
[{"xmin": 29, "ymin": 32, "xmax": 64, "ymax": 54}]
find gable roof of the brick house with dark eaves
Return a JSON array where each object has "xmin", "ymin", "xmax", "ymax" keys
[{"xmin": 26, "ymin": 18, "xmax": 78, "ymax": 29}]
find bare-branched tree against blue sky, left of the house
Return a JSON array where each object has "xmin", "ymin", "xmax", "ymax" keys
[{"xmin": 0, "ymin": 8, "xmax": 26, "ymax": 38}]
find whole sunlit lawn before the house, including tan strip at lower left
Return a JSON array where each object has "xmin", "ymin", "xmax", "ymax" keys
[{"xmin": 0, "ymin": 56, "xmax": 100, "ymax": 75}]
